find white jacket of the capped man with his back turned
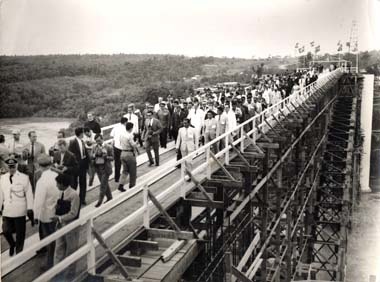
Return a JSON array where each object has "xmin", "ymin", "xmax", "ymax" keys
[{"xmin": 33, "ymin": 170, "xmax": 61, "ymax": 223}]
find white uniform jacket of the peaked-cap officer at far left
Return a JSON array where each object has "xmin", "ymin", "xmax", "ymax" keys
[{"xmin": 0, "ymin": 171, "xmax": 33, "ymax": 217}]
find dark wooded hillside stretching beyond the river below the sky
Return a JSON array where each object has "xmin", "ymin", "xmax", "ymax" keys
[{"xmin": 0, "ymin": 51, "xmax": 380, "ymax": 130}]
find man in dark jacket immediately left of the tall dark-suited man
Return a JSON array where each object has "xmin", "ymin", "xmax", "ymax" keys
[{"xmin": 52, "ymin": 139, "xmax": 79, "ymax": 187}]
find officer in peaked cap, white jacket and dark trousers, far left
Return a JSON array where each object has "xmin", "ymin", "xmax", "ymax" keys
[{"xmin": 0, "ymin": 158, "xmax": 34, "ymax": 256}]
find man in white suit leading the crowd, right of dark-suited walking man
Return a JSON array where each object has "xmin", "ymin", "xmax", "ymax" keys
[{"xmin": 176, "ymin": 118, "xmax": 198, "ymax": 171}]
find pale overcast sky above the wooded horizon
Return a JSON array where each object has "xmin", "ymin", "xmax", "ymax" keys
[{"xmin": 0, "ymin": 0, "xmax": 380, "ymax": 58}]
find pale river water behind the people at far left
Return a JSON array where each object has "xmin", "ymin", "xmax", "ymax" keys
[{"xmin": 0, "ymin": 117, "xmax": 74, "ymax": 150}]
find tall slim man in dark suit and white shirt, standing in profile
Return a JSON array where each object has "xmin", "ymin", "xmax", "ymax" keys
[{"xmin": 69, "ymin": 127, "xmax": 90, "ymax": 205}]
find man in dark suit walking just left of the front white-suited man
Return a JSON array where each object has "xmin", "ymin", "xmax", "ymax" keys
[{"xmin": 143, "ymin": 111, "xmax": 162, "ymax": 166}]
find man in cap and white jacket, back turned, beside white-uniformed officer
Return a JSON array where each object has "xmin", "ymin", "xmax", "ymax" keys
[{"xmin": 33, "ymin": 154, "xmax": 60, "ymax": 269}]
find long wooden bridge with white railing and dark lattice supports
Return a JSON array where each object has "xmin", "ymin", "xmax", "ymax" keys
[{"xmin": 1, "ymin": 68, "xmax": 361, "ymax": 281}]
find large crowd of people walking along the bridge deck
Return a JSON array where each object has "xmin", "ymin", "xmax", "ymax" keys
[{"xmin": 0, "ymin": 67, "xmax": 318, "ymax": 275}]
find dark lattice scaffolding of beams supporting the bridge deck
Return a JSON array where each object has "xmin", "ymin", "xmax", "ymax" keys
[{"xmin": 185, "ymin": 72, "xmax": 358, "ymax": 282}]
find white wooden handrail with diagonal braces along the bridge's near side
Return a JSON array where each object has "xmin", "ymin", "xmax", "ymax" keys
[{"xmin": 1, "ymin": 69, "xmax": 342, "ymax": 281}]
